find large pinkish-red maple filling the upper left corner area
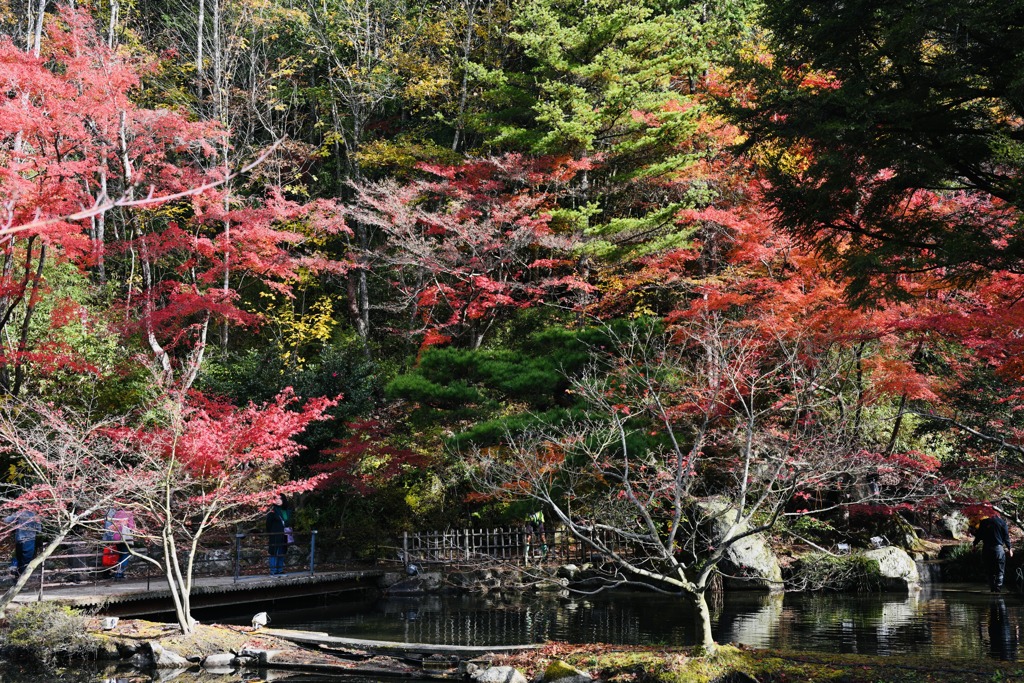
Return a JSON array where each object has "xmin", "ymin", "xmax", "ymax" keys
[{"xmin": 0, "ymin": 5, "xmax": 347, "ymax": 395}]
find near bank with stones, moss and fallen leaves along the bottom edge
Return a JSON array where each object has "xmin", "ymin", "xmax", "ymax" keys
[{"xmin": 2, "ymin": 617, "xmax": 1024, "ymax": 683}]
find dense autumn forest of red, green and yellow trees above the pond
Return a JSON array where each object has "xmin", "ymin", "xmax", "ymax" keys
[{"xmin": 0, "ymin": 0, "xmax": 1024, "ymax": 643}]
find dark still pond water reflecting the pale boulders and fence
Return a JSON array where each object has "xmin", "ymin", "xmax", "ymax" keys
[{"xmin": 270, "ymin": 584, "xmax": 1024, "ymax": 660}]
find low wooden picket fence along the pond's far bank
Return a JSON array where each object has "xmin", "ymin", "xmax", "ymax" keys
[{"xmin": 395, "ymin": 526, "xmax": 629, "ymax": 566}]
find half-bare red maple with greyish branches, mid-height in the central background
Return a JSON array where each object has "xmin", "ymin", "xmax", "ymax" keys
[{"xmin": 348, "ymin": 155, "xmax": 590, "ymax": 348}]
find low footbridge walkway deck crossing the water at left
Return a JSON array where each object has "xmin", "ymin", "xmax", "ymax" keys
[{"xmin": 15, "ymin": 569, "xmax": 384, "ymax": 616}]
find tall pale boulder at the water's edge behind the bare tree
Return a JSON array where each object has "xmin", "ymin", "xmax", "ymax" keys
[{"xmin": 697, "ymin": 499, "xmax": 782, "ymax": 591}]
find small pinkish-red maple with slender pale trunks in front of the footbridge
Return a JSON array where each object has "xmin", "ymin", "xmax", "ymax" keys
[{"xmin": 113, "ymin": 390, "xmax": 337, "ymax": 633}]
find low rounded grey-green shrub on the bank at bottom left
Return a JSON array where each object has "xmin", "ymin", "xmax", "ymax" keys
[{"xmin": 0, "ymin": 602, "xmax": 97, "ymax": 668}]
